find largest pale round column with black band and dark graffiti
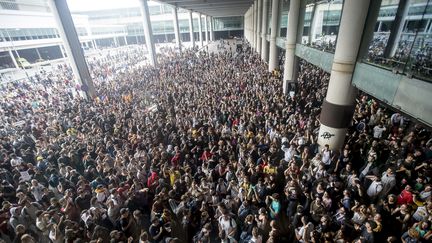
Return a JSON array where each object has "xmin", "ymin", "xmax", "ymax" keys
[{"xmin": 318, "ymin": 0, "xmax": 370, "ymax": 150}]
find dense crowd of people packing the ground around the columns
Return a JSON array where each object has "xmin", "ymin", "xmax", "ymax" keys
[{"xmin": 0, "ymin": 38, "xmax": 432, "ymax": 243}]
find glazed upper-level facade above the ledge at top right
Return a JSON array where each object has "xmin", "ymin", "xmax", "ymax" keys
[{"xmin": 363, "ymin": 1, "xmax": 432, "ymax": 81}]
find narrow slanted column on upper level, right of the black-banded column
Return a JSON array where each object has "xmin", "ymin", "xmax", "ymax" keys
[{"xmin": 384, "ymin": 0, "xmax": 410, "ymax": 58}]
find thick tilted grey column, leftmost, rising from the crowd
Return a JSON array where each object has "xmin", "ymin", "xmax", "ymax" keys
[{"xmin": 48, "ymin": 0, "xmax": 96, "ymax": 99}]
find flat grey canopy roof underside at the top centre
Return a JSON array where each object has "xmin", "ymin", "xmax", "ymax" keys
[{"xmin": 158, "ymin": 0, "xmax": 253, "ymax": 17}]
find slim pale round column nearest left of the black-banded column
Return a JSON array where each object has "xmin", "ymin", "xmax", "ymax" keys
[{"xmin": 283, "ymin": 0, "xmax": 300, "ymax": 94}]
